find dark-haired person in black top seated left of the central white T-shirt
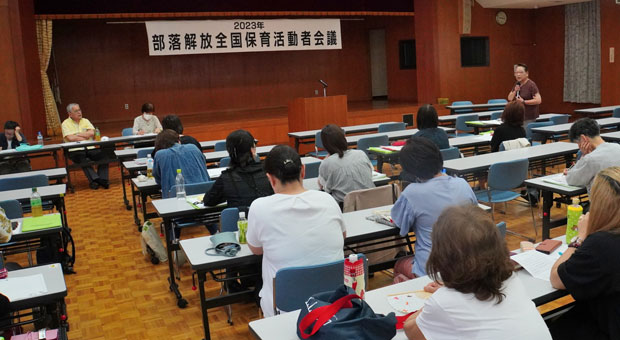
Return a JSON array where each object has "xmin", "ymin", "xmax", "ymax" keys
[{"xmin": 204, "ymin": 130, "xmax": 273, "ymax": 212}]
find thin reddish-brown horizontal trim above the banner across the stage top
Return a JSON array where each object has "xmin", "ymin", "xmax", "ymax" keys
[{"xmin": 35, "ymin": 11, "xmax": 415, "ymax": 20}]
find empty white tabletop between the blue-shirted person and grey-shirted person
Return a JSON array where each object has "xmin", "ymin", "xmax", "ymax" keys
[{"xmin": 443, "ymin": 142, "xmax": 579, "ymax": 176}]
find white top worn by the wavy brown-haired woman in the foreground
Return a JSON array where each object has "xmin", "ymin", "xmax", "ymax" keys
[{"xmin": 416, "ymin": 275, "xmax": 551, "ymax": 340}]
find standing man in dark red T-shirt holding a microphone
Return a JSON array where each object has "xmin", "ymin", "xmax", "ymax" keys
[{"xmin": 508, "ymin": 63, "xmax": 542, "ymax": 127}]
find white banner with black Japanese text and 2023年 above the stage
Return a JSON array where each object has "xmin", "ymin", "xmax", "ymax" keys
[{"xmin": 146, "ymin": 19, "xmax": 342, "ymax": 56}]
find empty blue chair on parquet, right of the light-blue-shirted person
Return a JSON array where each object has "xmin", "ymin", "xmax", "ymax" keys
[{"xmin": 476, "ymin": 158, "xmax": 538, "ymax": 242}]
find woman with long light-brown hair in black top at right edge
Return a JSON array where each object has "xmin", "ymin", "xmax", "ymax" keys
[{"xmin": 549, "ymin": 166, "xmax": 620, "ymax": 339}]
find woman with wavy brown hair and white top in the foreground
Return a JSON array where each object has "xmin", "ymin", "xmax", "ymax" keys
[{"xmin": 404, "ymin": 205, "xmax": 551, "ymax": 340}]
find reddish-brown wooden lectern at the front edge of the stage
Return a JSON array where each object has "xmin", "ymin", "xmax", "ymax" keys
[{"xmin": 288, "ymin": 95, "xmax": 348, "ymax": 132}]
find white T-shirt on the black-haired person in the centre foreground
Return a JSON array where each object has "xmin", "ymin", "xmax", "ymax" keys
[{"xmin": 247, "ymin": 190, "xmax": 345, "ymax": 317}]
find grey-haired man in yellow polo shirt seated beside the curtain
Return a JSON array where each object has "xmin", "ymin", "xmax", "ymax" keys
[{"xmin": 62, "ymin": 103, "xmax": 110, "ymax": 190}]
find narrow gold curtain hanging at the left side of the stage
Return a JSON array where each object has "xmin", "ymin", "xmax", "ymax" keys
[{"xmin": 36, "ymin": 20, "xmax": 62, "ymax": 136}]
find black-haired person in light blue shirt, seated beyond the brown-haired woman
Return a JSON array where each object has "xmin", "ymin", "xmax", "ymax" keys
[{"xmin": 392, "ymin": 137, "xmax": 478, "ymax": 283}]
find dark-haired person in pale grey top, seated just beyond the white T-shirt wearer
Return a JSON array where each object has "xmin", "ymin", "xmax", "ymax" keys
[{"xmin": 319, "ymin": 124, "xmax": 375, "ymax": 204}]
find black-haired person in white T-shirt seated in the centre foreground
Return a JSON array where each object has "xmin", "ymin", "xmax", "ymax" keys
[{"xmin": 247, "ymin": 145, "xmax": 346, "ymax": 317}]
